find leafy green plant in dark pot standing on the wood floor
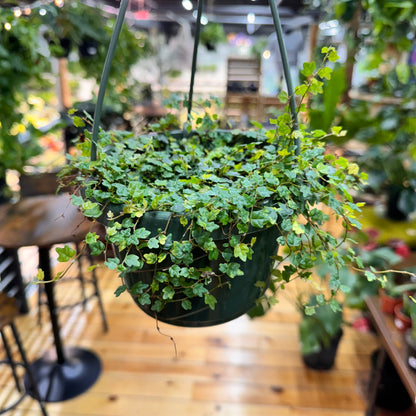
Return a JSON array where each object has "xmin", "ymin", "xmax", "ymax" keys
[{"xmin": 298, "ymin": 295, "xmax": 344, "ymax": 370}]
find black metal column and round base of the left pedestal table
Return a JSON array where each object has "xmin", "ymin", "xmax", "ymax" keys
[{"xmin": 24, "ymin": 248, "xmax": 101, "ymax": 402}]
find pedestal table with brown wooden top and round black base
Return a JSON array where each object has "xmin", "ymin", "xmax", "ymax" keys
[{"xmin": 0, "ymin": 194, "xmax": 101, "ymax": 402}]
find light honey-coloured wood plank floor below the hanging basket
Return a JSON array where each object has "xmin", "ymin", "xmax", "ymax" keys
[{"xmin": 0, "ymin": 262, "xmax": 412, "ymax": 416}]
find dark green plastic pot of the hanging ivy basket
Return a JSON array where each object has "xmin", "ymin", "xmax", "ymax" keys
[{"xmin": 103, "ymin": 211, "xmax": 280, "ymax": 327}]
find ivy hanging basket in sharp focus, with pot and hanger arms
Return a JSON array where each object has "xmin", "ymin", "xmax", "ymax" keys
[{"xmin": 49, "ymin": 1, "xmax": 363, "ymax": 326}]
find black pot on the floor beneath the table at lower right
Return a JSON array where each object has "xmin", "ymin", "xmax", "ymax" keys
[{"xmin": 370, "ymin": 349, "xmax": 412, "ymax": 412}]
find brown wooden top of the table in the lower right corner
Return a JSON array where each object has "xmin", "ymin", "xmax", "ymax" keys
[{"xmin": 366, "ymin": 296, "xmax": 416, "ymax": 403}]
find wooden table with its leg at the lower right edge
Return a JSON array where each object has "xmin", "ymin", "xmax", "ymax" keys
[{"xmin": 366, "ymin": 296, "xmax": 416, "ymax": 416}]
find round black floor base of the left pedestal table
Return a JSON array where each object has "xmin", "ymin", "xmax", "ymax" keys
[{"xmin": 24, "ymin": 347, "xmax": 101, "ymax": 402}]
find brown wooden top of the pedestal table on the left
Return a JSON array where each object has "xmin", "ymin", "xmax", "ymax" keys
[{"xmin": 0, "ymin": 194, "xmax": 92, "ymax": 248}]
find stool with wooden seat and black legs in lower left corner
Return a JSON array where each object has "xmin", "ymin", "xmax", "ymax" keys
[{"xmin": 0, "ymin": 292, "xmax": 48, "ymax": 416}]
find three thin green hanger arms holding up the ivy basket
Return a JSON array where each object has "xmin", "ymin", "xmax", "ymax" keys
[{"xmin": 91, "ymin": 0, "xmax": 300, "ymax": 161}]
